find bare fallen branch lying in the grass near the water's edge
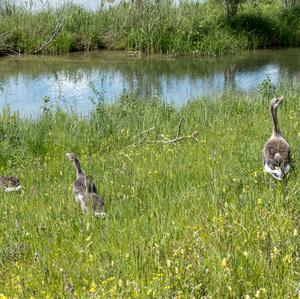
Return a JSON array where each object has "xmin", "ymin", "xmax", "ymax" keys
[{"xmin": 130, "ymin": 117, "xmax": 199, "ymax": 147}]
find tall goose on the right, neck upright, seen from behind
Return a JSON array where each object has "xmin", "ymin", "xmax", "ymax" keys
[{"xmin": 263, "ymin": 97, "xmax": 291, "ymax": 181}]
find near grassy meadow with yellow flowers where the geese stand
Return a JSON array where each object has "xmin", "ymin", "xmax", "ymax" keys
[{"xmin": 0, "ymin": 88, "xmax": 300, "ymax": 298}]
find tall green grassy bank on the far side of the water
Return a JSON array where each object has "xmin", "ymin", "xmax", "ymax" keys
[{"xmin": 0, "ymin": 0, "xmax": 300, "ymax": 55}]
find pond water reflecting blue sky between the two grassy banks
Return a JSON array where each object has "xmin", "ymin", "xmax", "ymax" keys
[{"xmin": 0, "ymin": 48, "xmax": 300, "ymax": 116}]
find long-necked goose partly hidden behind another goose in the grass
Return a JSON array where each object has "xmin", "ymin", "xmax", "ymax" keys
[{"xmin": 66, "ymin": 153, "xmax": 97, "ymax": 207}]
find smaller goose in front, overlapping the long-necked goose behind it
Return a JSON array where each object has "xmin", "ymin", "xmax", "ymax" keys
[{"xmin": 81, "ymin": 175, "xmax": 106, "ymax": 218}]
